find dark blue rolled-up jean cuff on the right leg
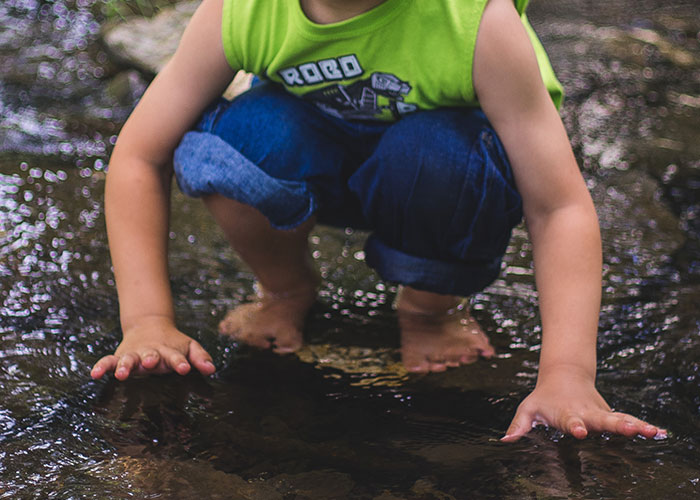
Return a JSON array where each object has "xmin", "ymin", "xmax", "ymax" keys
[{"xmin": 365, "ymin": 235, "xmax": 501, "ymax": 297}]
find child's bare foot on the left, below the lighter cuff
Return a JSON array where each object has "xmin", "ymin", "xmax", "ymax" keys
[{"xmin": 219, "ymin": 284, "xmax": 317, "ymax": 354}]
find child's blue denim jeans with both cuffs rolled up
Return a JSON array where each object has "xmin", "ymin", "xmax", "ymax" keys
[{"xmin": 174, "ymin": 83, "xmax": 522, "ymax": 296}]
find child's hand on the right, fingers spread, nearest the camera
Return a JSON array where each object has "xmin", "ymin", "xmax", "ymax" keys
[{"xmin": 501, "ymin": 368, "xmax": 666, "ymax": 443}]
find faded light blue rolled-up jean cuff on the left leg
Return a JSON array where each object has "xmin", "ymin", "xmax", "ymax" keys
[{"xmin": 173, "ymin": 132, "xmax": 317, "ymax": 229}]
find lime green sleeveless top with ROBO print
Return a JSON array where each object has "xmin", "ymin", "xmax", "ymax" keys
[{"xmin": 222, "ymin": 0, "xmax": 563, "ymax": 120}]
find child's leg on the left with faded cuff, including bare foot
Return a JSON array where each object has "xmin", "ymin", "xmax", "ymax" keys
[{"xmin": 174, "ymin": 85, "xmax": 372, "ymax": 352}]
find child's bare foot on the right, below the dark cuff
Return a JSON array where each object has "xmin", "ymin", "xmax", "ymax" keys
[{"xmin": 397, "ymin": 289, "xmax": 495, "ymax": 372}]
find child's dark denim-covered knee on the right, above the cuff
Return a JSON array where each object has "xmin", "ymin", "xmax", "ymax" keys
[{"xmin": 351, "ymin": 110, "xmax": 522, "ymax": 259}]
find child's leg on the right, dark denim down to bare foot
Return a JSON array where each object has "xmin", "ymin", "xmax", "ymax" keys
[{"xmin": 350, "ymin": 109, "xmax": 522, "ymax": 371}]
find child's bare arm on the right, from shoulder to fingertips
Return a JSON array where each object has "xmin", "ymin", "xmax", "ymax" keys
[{"xmin": 474, "ymin": 0, "xmax": 664, "ymax": 441}]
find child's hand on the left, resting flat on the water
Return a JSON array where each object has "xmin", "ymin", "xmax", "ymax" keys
[{"xmin": 90, "ymin": 318, "xmax": 216, "ymax": 380}]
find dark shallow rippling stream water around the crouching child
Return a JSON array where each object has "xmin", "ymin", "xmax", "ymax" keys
[{"xmin": 0, "ymin": 0, "xmax": 700, "ymax": 500}]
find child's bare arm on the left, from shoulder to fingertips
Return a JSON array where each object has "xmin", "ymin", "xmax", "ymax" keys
[{"xmin": 92, "ymin": 0, "xmax": 234, "ymax": 380}]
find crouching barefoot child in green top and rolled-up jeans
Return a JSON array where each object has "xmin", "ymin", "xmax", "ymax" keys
[{"xmin": 92, "ymin": 0, "xmax": 664, "ymax": 441}]
